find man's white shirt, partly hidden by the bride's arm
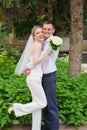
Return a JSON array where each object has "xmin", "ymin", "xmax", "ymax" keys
[{"xmin": 41, "ymin": 37, "xmax": 59, "ymax": 74}]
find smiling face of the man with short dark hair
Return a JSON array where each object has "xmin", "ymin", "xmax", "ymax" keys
[{"xmin": 43, "ymin": 24, "xmax": 55, "ymax": 40}]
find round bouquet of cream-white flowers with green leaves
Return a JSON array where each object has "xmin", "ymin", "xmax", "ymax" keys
[{"xmin": 49, "ymin": 36, "xmax": 63, "ymax": 51}]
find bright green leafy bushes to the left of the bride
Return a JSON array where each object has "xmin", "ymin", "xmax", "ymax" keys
[{"xmin": 0, "ymin": 51, "xmax": 31, "ymax": 127}]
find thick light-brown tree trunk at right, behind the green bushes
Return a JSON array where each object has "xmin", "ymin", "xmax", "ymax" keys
[{"xmin": 69, "ymin": 0, "xmax": 83, "ymax": 76}]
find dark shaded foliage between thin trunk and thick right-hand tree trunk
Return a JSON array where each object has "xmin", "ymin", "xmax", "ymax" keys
[{"xmin": 53, "ymin": 0, "xmax": 71, "ymax": 37}]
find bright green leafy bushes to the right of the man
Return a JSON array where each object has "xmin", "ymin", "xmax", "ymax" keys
[{"xmin": 57, "ymin": 59, "xmax": 87, "ymax": 126}]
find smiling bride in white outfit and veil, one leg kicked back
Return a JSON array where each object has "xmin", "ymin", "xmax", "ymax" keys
[{"xmin": 8, "ymin": 26, "xmax": 52, "ymax": 130}]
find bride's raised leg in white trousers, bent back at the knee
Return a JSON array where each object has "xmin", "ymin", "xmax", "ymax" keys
[{"xmin": 13, "ymin": 77, "xmax": 47, "ymax": 117}]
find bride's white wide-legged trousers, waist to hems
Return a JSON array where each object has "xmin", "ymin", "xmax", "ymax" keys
[{"xmin": 13, "ymin": 58, "xmax": 47, "ymax": 130}]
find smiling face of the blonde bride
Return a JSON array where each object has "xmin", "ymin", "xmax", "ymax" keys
[{"xmin": 34, "ymin": 28, "xmax": 44, "ymax": 43}]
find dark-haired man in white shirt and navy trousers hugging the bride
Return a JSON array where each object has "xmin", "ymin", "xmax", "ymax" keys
[{"xmin": 24, "ymin": 21, "xmax": 59, "ymax": 130}]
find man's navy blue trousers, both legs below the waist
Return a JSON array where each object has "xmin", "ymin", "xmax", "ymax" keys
[{"xmin": 42, "ymin": 74, "xmax": 59, "ymax": 130}]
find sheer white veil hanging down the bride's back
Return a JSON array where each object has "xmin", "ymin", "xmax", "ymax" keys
[{"xmin": 15, "ymin": 35, "xmax": 34, "ymax": 75}]
